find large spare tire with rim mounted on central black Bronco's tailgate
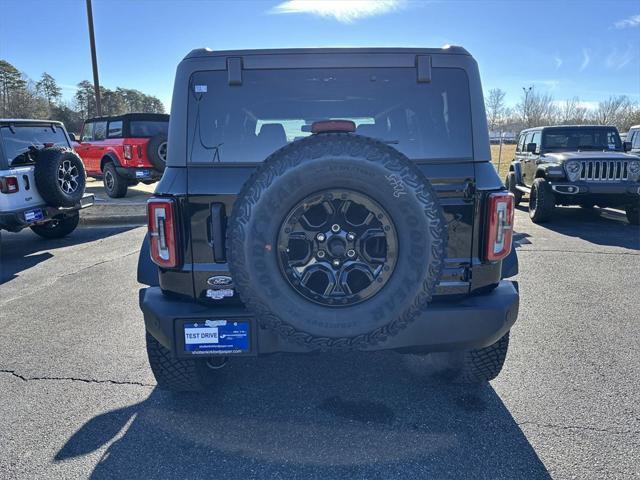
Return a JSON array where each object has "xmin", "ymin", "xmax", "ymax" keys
[{"xmin": 227, "ymin": 133, "xmax": 446, "ymax": 350}]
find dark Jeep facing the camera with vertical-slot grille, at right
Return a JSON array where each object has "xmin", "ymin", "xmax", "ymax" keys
[{"xmin": 505, "ymin": 125, "xmax": 640, "ymax": 225}]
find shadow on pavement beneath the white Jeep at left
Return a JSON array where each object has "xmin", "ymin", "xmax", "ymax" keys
[{"xmin": 0, "ymin": 226, "xmax": 137, "ymax": 285}]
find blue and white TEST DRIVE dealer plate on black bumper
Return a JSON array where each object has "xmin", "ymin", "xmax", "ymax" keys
[{"xmin": 183, "ymin": 320, "xmax": 249, "ymax": 354}]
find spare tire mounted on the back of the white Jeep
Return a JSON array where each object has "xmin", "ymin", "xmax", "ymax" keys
[{"xmin": 33, "ymin": 147, "xmax": 86, "ymax": 207}]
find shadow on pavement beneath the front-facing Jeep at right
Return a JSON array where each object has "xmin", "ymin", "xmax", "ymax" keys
[{"xmin": 517, "ymin": 206, "xmax": 640, "ymax": 250}]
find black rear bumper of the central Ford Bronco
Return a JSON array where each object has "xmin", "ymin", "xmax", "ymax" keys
[{"xmin": 140, "ymin": 280, "xmax": 519, "ymax": 357}]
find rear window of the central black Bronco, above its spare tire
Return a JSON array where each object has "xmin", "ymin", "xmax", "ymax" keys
[{"xmin": 189, "ymin": 68, "xmax": 472, "ymax": 163}]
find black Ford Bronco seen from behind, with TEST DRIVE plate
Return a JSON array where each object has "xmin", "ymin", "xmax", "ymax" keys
[{"xmin": 138, "ymin": 47, "xmax": 519, "ymax": 390}]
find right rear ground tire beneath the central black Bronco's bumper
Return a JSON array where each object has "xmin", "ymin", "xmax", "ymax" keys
[{"xmin": 429, "ymin": 332, "xmax": 509, "ymax": 384}]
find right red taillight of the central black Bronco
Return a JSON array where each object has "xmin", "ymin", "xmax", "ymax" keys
[{"xmin": 485, "ymin": 192, "xmax": 514, "ymax": 262}]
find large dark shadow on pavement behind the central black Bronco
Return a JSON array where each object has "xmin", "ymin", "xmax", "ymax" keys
[{"xmin": 55, "ymin": 352, "xmax": 551, "ymax": 479}]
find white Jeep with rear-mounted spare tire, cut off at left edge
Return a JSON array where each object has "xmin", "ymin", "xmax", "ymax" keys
[{"xmin": 0, "ymin": 119, "xmax": 94, "ymax": 238}]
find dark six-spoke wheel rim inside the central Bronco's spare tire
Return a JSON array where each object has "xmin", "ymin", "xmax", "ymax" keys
[{"xmin": 277, "ymin": 190, "xmax": 398, "ymax": 306}]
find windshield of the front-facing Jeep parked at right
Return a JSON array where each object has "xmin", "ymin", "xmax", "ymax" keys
[{"xmin": 542, "ymin": 127, "xmax": 622, "ymax": 151}]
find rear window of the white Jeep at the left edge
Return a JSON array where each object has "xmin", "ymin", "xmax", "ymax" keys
[{"xmin": 0, "ymin": 125, "xmax": 69, "ymax": 166}]
